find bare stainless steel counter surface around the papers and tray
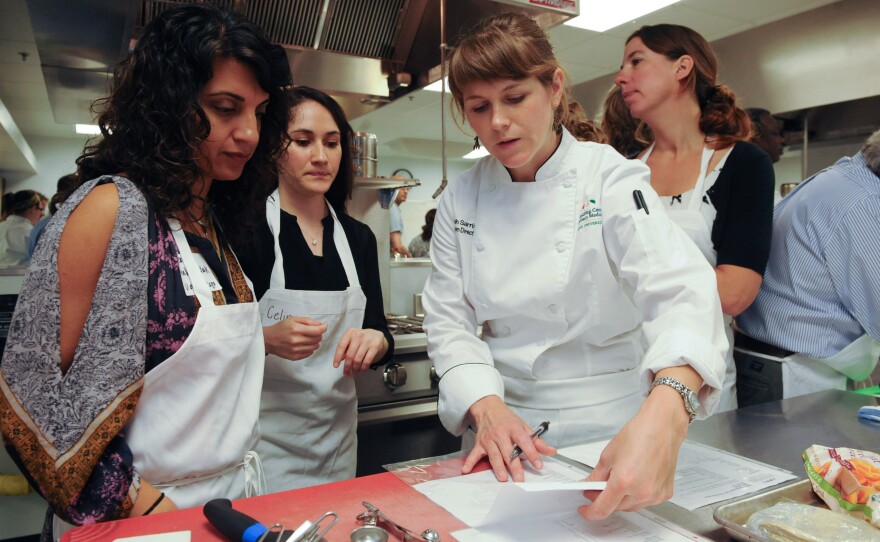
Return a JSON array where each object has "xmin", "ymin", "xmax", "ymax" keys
[{"xmin": 650, "ymin": 390, "xmax": 880, "ymax": 540}]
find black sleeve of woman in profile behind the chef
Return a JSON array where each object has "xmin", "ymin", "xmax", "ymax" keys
[{"xmin": 706, "ymin": 141, "xmax": 776, "ymax": 275}]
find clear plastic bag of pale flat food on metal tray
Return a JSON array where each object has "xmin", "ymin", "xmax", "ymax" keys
[{"xmin": 746, "ymin": 502, "xmax": 880, "ymax": 542}]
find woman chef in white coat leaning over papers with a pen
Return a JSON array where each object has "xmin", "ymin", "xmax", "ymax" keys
[{"xmin": 422, "ymin": 9, "xmax": 727, "ymax": 519}]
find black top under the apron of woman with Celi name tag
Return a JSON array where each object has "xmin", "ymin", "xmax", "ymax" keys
[{"xmin": 235, "ymin": 211, "xmax": 394, "ymax": 363}]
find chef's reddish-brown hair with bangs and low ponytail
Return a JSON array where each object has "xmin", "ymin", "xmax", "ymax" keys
[{"xmin": 449, "ymin": 11, "xmax": 605, "ymax": 142}]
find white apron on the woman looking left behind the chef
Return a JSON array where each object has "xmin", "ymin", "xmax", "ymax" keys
[{"xmin": 641, "ymin": 145, "xmax": 737, "ymax": 412}]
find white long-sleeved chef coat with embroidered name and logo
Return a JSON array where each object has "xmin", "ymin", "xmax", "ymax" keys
[{"xmin": 422, "ymin": 131, "xmax": 728, "ymax": 445}]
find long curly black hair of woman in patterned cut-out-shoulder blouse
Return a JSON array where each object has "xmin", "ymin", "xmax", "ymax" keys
[{"xmin": 74, "ymin": 4, "xmax": 291, "ymax": 240}]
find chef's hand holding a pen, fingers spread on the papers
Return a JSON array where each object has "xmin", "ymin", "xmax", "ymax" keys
[{"xmin": 461, "ymin": 395, "xmax": 556, "ymax": 482}]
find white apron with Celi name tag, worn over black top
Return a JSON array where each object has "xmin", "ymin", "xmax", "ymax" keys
[{"xmin": 257, "ymin": 190, "xmax": 367, "ymax": 493}]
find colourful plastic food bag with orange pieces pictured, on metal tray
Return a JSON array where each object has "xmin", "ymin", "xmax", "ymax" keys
[{"xmin": 803, "ymin": 444, "xmax": 880, "ymax": 527}]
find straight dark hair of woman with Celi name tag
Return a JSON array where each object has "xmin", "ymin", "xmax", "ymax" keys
[{"xmin": 287, "ymin": 86, "xmax": 354, "ymax": 213}]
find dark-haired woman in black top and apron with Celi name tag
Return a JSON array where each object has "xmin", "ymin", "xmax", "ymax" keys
[{"xmin": 239, "ymin": 87, "xmax": 394, "ymax": 492}]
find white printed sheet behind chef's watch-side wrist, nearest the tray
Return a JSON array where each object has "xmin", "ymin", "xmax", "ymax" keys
[{"xmin": 558, "ymin": 440, "xmax": 797, "ymax": 510}]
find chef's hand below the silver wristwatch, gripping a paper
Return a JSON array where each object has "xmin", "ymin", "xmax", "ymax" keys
[{"xmin": 578, "ymin": 370, "xmax": 701, "ymax": 520}]
